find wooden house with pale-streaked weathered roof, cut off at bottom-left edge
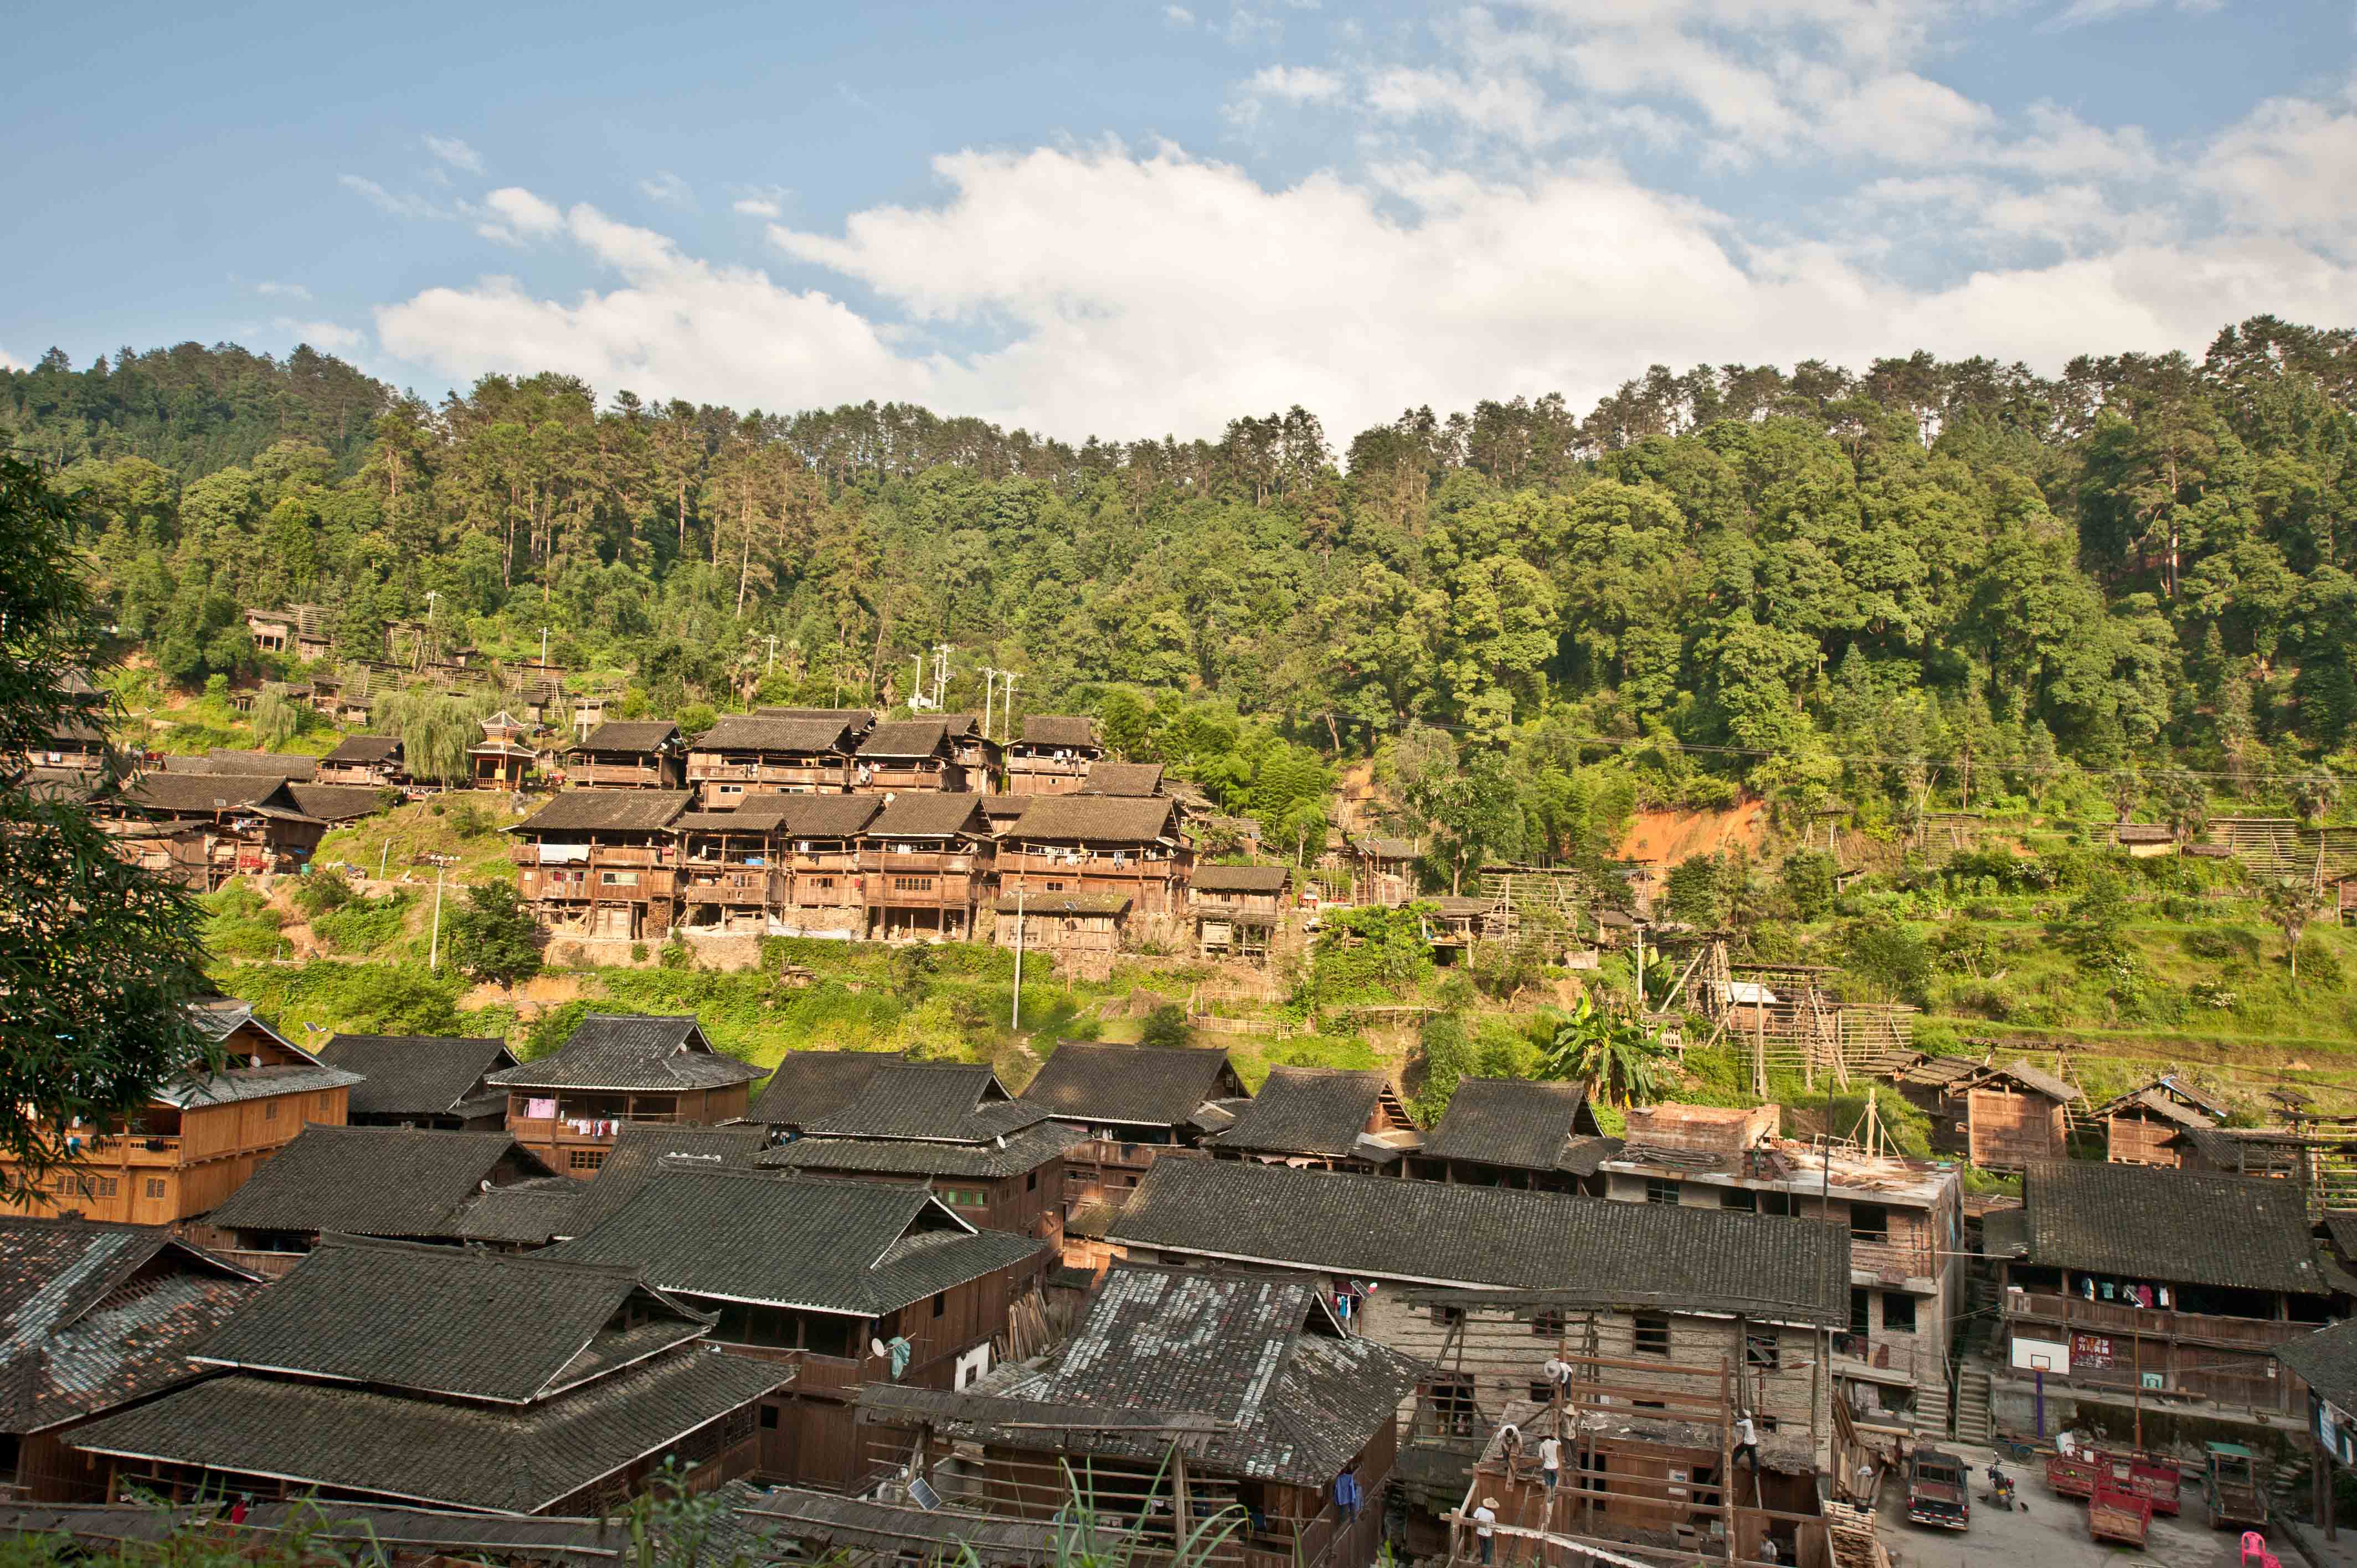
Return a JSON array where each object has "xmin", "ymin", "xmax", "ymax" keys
[{"xmin": 0, "ymin": 1219, "xmax": 261, "ymax": 1502}]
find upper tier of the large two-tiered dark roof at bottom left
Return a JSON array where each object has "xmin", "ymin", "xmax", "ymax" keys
[{"xmin": 198, "ymin": 1235, "xmax": 709, "ymax": 1405}]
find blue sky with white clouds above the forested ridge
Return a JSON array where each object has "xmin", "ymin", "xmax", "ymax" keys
[{"xmin": 0, "ymin": 0, "xmax": 2357, "ymax": 436}]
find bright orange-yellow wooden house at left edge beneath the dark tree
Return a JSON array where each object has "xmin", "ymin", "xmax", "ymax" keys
[{"xmin": 0, "ymin": 1000, "xmax": 358, "ymax": 1226}]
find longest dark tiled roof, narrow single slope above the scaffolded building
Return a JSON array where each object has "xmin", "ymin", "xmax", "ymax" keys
[{"xmin": 1110, "ymin": 1160, "xmax": 1850, "ymax": 1325}]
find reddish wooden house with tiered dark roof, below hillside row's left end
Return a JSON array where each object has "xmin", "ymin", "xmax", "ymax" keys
[{"xmin": 488, "ymin": 1014, "xmax": 761, "ymax": 1177}]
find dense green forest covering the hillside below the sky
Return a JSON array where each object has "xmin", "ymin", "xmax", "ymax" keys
[{"xmin": 0, "ymin": 318, "xmax": 2357, "ymax": 858}]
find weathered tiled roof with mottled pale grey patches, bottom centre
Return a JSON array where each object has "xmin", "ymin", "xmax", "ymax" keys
[{"xmin": 938, "ymin": 1264, "xmax": 1424, "ymax": 1488}]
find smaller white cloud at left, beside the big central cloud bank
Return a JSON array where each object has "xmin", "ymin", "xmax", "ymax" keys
[{"xmin": 377, "ymin": 198, "xmax": 933, "ymax": 408}]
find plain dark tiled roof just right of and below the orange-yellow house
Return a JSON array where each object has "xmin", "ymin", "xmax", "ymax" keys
[{"xmin": 205, "ymin": 1127, "xmax": 556, "ymax": 1238}]
